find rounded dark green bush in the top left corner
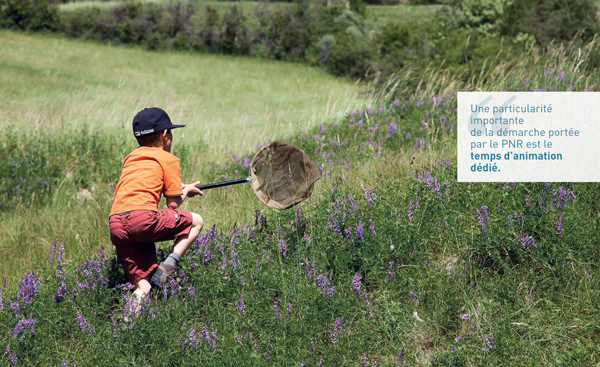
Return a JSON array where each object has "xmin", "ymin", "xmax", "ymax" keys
[{"xmin": 0, "ymin": 0, "xmax": 58, "ymax": 31}]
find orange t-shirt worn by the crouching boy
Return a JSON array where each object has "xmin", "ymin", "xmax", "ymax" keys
[{"xmin": 109, "ymin": 147, "xmax": 183, "ymax": 216}]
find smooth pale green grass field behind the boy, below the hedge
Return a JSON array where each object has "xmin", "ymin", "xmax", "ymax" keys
[{"xmin": 0, "ymin": 32, "xmax": 368, "ymax": 160}]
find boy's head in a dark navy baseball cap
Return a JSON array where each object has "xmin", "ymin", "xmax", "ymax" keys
[{"xmin": 132, "ymin": 107, "xmax": 185, "ymax": 151}]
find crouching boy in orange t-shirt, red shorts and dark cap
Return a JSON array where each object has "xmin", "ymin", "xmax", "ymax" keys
[{"xmin": 109, "ymin": 107, "xmax": 204, "ymax": 300}]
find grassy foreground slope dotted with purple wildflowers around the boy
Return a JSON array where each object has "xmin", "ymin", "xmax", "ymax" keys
[{"xmin": 0, "ymin": 13, "xmax": 600, "ymax": 366}]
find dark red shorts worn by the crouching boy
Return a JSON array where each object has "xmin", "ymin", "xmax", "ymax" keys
[{"xmin": 108, "ymin": 208, "xmax": 193, "ymax": 285}]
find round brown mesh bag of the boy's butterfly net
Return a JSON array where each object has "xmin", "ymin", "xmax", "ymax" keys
[{"xmin": 250, "ymin": 141, "xmax": 321, "ymax": 209}]
